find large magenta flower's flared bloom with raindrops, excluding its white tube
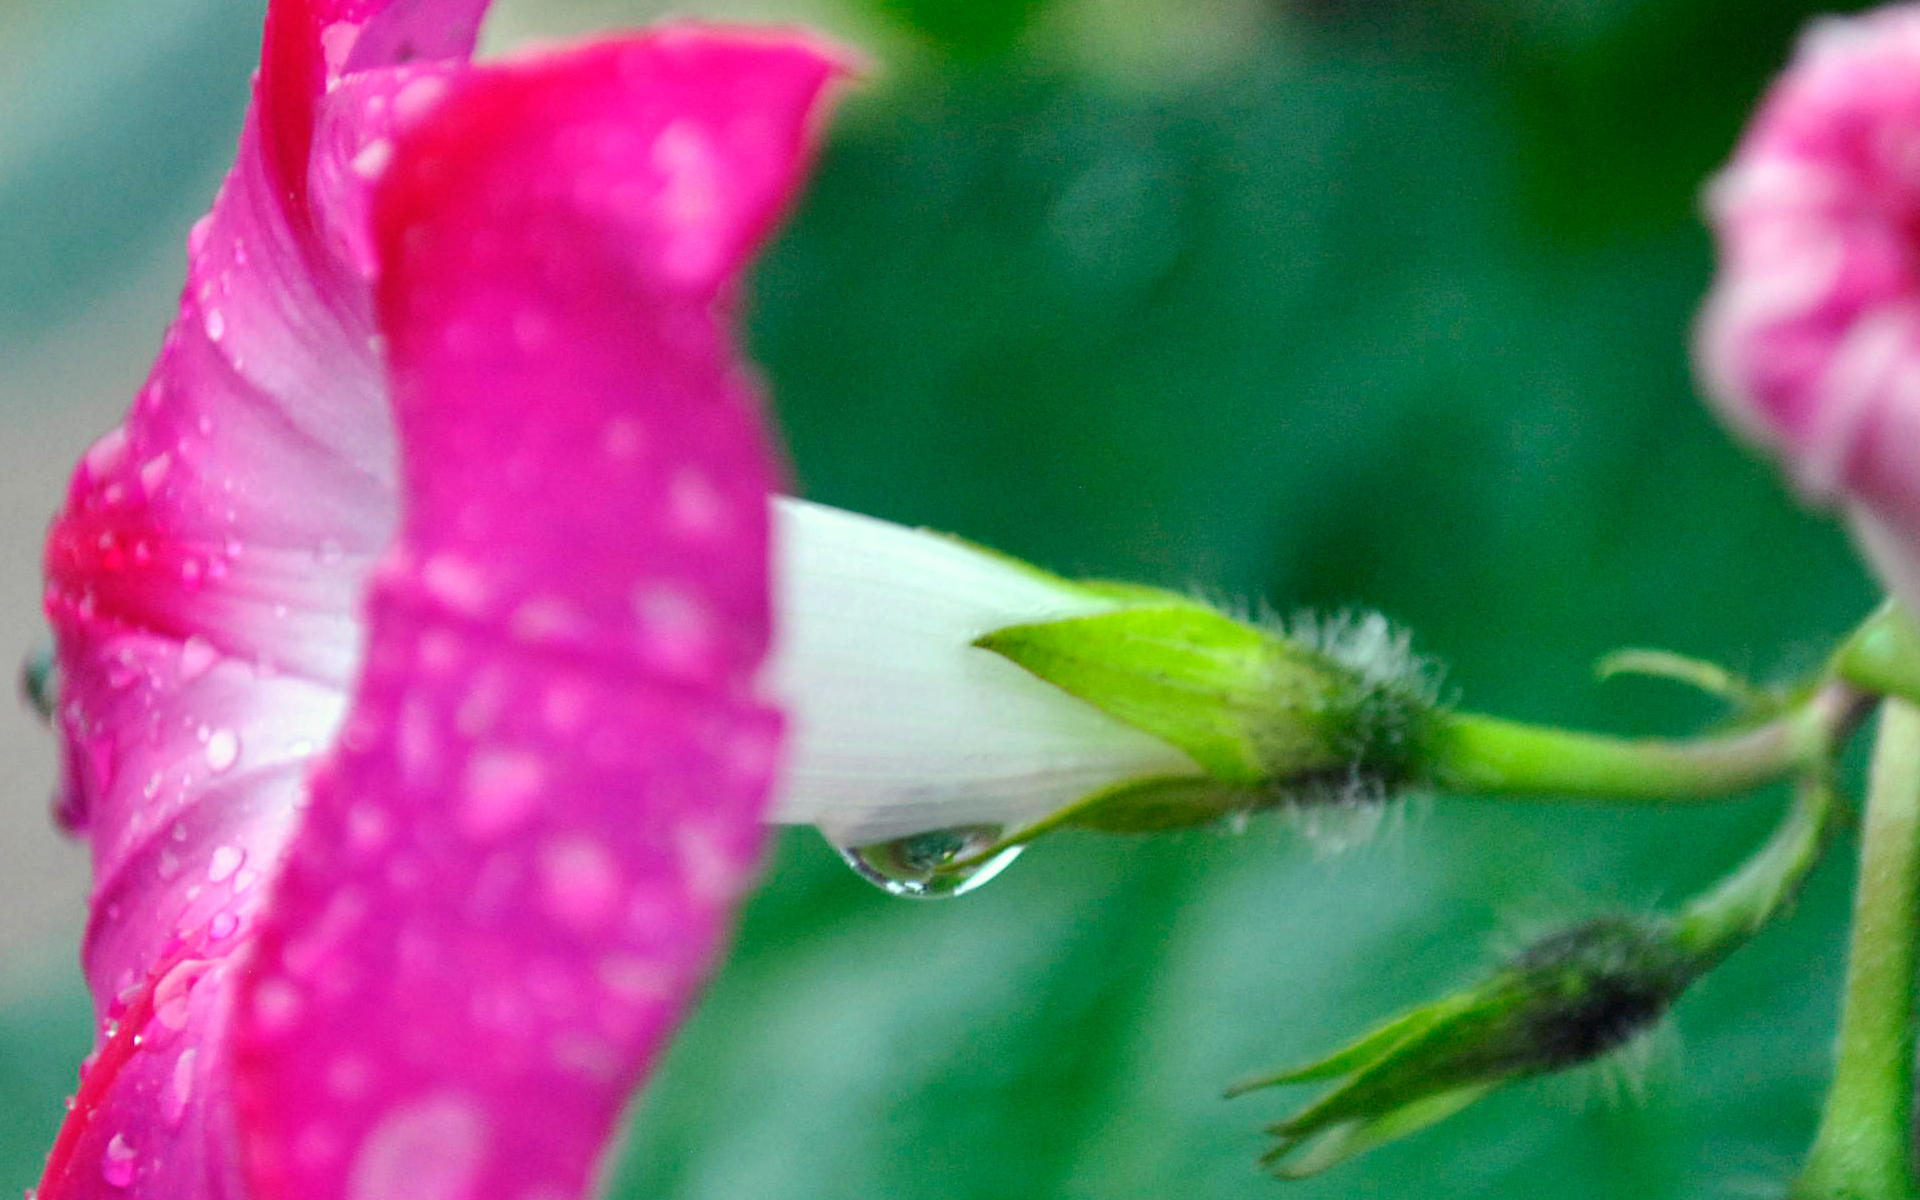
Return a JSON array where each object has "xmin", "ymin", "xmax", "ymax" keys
[{"xmin": 40, "ymin": 0, "xmax": 841, "ymax": 1200}]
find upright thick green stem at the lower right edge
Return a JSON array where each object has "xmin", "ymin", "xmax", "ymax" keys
[{"xmin": 1793, "ymin": 701, "xmax": 1920, "ymax": 1200}]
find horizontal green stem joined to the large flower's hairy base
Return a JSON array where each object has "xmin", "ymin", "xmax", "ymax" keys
[{"xmin": 1427, "ymin": 685, "xmax": 1859, "ymax": 804}]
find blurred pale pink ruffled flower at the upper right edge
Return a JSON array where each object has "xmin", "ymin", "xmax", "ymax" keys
[{"xmin": 1699, "ymin": 6, "xmax": 1920, "ymax": 603}]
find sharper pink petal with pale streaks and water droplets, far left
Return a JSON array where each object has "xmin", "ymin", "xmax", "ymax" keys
[{"xmin": 40, "ymin": 2, "xmax": 478, "ymax": 1200}]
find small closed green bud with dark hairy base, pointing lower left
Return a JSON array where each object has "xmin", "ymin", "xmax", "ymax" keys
[{"xmin": 1227, "ymin": 916, "xmax": 1707, "ymax": 1179}]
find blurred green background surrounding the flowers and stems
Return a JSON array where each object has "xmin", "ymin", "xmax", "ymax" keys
[{"xmin": 0, "ymin": 0, "xmax": 1874, "ymax": 1200}]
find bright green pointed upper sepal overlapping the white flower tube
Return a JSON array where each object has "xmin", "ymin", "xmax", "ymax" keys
[{"xmin": 973, "ymin": 601, "xmax": 1371, "ymax": 787}]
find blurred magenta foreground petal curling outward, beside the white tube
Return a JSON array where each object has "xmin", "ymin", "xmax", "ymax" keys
[{"xmin": 234, "ymin": 29, "xmax": 837, "ymax": 1200}]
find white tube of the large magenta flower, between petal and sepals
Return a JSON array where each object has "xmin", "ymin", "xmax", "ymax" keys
[{"xmin": 772, "ymin": 497, "xmax": 1200, "ymax": 845}]
